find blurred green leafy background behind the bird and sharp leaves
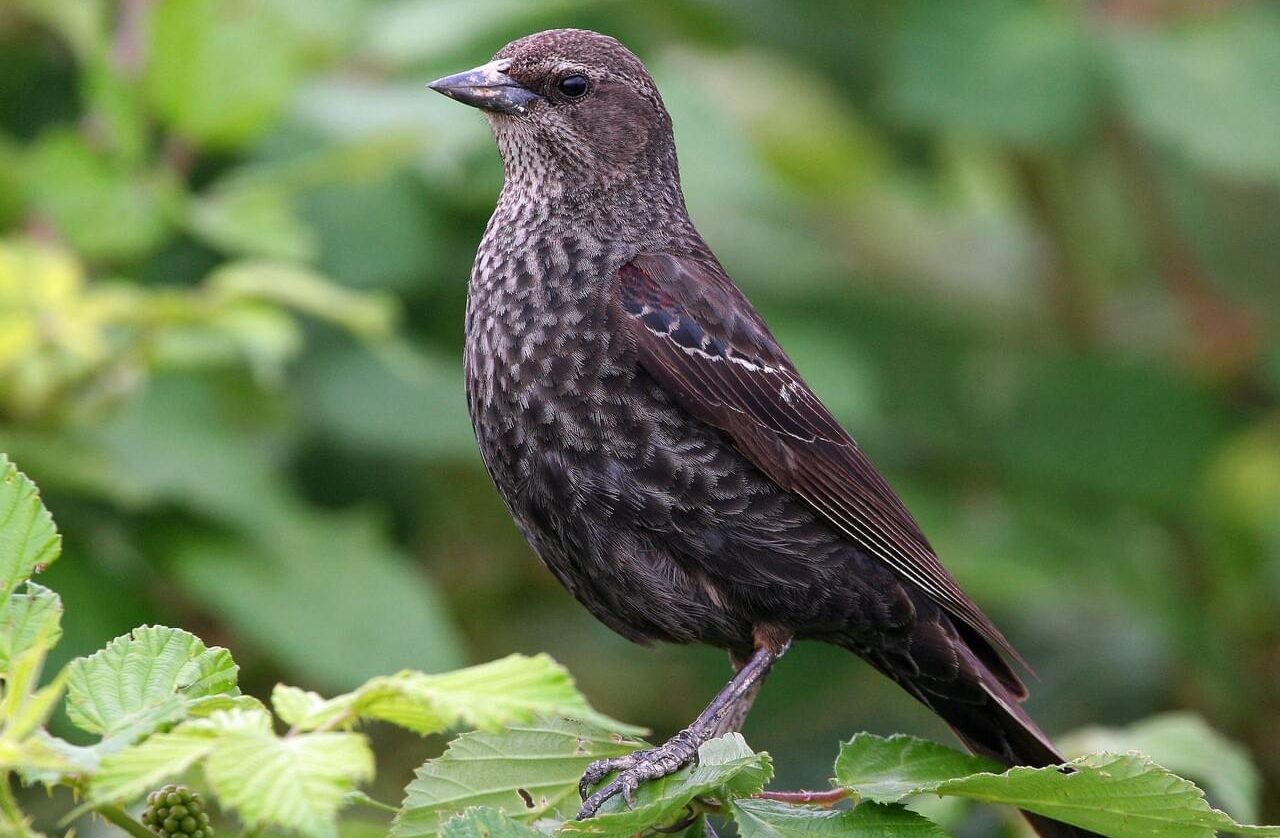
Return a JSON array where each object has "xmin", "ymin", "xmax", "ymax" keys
[{"xmin": 0, "ymin": 0, "xmax": 1280, "ymax": 821}]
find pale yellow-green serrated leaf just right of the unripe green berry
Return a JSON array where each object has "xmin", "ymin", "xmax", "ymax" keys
[{"xmin": 205, "ymin": 725, "xmax": 374, "ymax": 835}]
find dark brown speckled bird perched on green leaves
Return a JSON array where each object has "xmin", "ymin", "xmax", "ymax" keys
[{"xmin": 429, "ymin": 29, "xmax": 1092, "ymax": 838}]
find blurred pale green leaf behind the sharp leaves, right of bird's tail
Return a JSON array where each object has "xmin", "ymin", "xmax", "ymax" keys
[{"xmin": 1059, "ymin": 713, "xmax": 1262, "ymax": 821}]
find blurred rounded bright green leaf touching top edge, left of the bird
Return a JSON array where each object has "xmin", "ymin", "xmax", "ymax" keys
[{"xmin": 143, "ymin": 0, "xmax": 300, "ymax": 146}]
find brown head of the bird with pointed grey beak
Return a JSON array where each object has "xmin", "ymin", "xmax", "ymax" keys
[{"xmin": 430, "ymin": 29, "xmax": 676, "ymax": 204}]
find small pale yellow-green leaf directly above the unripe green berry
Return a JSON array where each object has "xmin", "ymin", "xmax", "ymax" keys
[{"xmin": 88, "ymin": 723, "xmax": 219, "ymax": 803}]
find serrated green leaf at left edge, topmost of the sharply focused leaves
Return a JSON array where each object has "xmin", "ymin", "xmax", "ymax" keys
[{"xmin": 0, "ymin": 454, "xmax": 63, "ymax": 596}]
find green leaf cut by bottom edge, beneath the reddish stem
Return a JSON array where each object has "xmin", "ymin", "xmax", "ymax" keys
[{"xmin": 731, "ymin": 798, "xmax": 946, "ymax": 838}]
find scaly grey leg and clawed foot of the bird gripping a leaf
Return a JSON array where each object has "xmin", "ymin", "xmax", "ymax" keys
[{"xmin": 577, "ymin": 638, "xmax": 791, "ymax": 820}]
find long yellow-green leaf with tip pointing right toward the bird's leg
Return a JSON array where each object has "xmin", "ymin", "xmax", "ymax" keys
[{"xmin": 271, "ymin": 655, "xmax": 644, "ymax": 734}]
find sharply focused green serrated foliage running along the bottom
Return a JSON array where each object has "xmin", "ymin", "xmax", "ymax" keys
[{"xmin": 0, "ymin": 454, "xmax": 1280, "ymax": 838}]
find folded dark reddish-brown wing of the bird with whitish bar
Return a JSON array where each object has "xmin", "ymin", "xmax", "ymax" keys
[{"xmin": 617, "ymin": 253, "xmax": 1027, "ymax": 667}]
